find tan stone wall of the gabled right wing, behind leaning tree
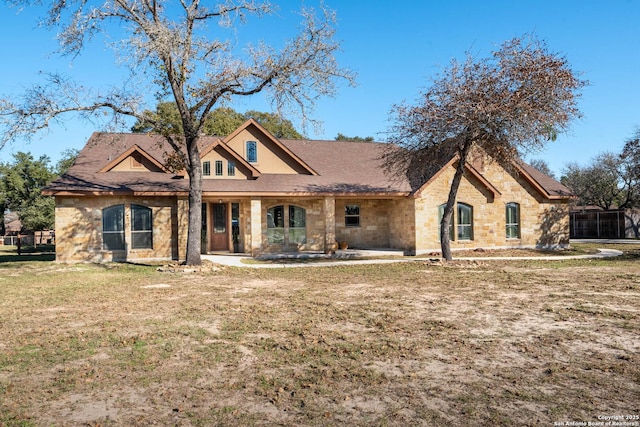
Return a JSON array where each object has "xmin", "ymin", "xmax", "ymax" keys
[{"xmin": 416, "ymin": 162, "xmax": 569, "ymax": 253}]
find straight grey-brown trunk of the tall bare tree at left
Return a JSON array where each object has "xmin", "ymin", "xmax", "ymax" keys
[{"xmin": 186, "ymin": 137, "xmax": 202, "ymax": 265}]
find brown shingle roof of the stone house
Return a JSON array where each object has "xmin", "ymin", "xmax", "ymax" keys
[{"xmin": 45, "ymin": 133, "xmax": 571, "ymax": 198}]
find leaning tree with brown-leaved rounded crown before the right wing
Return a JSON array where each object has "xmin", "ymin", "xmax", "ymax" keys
[{"xmin": 385, "ymin": 36, "xmax": 587, "ymax": 260}]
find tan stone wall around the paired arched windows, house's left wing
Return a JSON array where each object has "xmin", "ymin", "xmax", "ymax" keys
[{"xmin": 55, "ymin": 196, "xmax": 179, "ymax": 262}]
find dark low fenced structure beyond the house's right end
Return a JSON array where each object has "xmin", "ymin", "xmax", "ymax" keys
[{"xmin": 569, "ymin": 211, "xmax": 625, "ymax": 239}]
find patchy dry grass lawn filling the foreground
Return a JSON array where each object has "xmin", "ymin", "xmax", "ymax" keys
[{"xmin": 0, "ymin": 246, "xmax": 640, "ymax": 426}]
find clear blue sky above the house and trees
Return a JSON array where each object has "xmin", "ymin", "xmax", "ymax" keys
[{"xmin": 0, "ymin": 0, "xmax": 640, "ymax": 177}]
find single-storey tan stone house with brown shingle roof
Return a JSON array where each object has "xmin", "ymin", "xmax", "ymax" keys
[{"xmin": 45, "ymin": 120, "xmax": 570, "ymax": 262}]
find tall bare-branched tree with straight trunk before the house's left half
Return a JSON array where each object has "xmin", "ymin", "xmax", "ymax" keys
[{"xmin": 0, "ymin": 0, "xmax": 354, "ymax": 265}]
